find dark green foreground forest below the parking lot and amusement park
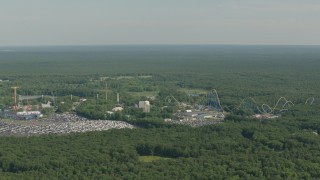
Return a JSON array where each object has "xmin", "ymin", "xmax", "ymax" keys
[{"xmin": 0, "ymin": 111, "xmax": 320, "ymax": 179}]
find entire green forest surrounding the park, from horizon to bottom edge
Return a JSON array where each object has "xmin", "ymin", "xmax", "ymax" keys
[{"xmin": 0, "ymin": 46, "xmax": 320, "ymax": 179}]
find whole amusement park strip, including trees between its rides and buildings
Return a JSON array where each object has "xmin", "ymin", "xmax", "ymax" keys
[{"xmin": 0, "ymin": 80, "xmax": 315, "ymax": 132}]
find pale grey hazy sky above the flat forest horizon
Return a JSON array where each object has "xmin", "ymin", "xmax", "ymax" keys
[{"xmin": 0, "ymin": 0, "xmax": 320, "ymax": 46}]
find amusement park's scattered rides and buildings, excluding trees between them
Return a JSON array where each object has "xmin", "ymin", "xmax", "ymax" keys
[{"xmin": 1, "ymin": 86, "xmax": 308, "ymax": 123}]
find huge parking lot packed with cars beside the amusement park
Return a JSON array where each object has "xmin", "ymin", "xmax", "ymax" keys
[{"xmin": 0, "ymin": 114, "xmax": 134, "ymax": 136}]
